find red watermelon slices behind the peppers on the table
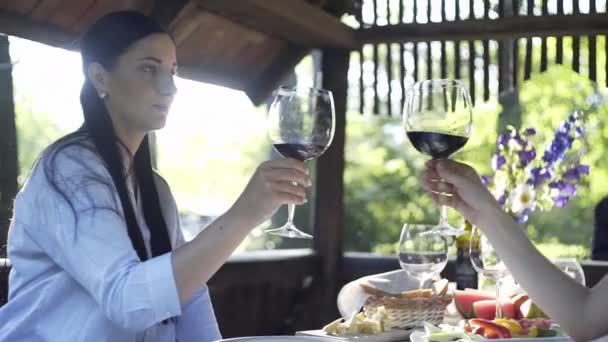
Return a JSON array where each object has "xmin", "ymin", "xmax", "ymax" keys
[{"xmin": 454, "ymin": 289, "xmax": 549, "ymax": 320}]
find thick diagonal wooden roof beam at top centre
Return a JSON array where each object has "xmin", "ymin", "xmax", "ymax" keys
[{"xmin": 198, "ymin": 0, "xmax": 355, "ymax": 48}]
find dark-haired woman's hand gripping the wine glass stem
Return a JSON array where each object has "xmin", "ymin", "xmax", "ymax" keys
[{"xmin": 231, "ymin": 158, "xmax": 311, "ymax": 228}]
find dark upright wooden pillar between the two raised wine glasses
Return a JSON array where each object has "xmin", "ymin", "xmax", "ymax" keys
[{"xmin": 312, "ymin": 49, "xmax": 350, "ymax": 322}]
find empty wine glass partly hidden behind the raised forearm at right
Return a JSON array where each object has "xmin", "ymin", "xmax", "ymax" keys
[{"xmin": 469, "ymin": 227, "xmax": 509, "ymax": 318}]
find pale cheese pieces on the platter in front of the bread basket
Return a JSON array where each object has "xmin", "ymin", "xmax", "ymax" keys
[{"xmin": 323, "ymin": 306, "xmax": 391, "ymax": 336}]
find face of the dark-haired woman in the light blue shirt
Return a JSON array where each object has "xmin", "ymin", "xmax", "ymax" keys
[{"xmin": 96, "ymin": 34, "xmax": 177, "ymax": 133}]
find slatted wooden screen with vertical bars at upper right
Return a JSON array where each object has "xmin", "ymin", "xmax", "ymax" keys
[{"xmin": 350, "ymin": 0, "xmax": 608, "ymax": 115}]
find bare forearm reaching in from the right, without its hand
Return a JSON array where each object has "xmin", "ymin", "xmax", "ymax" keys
[{"xmin": 478, "ymin": 204, "xmax": 608, "ymax": 341}]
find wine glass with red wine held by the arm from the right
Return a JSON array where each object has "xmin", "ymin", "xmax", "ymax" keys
[{"xmin": 403, "ymin": 79, "xmax": 473, "ymax": 235}]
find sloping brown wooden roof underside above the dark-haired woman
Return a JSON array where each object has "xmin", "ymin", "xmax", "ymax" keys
[{"xmin": 0, "ymin": 0, "xmax": 355, "ymax": 104}]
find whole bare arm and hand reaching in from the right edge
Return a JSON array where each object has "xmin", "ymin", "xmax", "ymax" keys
[{"xmin": 424, "ymin": 161, "xmax": 608, "ymax": 341}]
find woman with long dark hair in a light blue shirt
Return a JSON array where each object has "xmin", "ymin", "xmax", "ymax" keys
[{"xmin": 0, "ymin": 12, "xmax": 310, "ymax": 342}]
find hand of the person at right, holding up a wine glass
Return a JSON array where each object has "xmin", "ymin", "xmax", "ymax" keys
[{"xmin": 423, "ymin": 159, "xmax": 500, "ymax": 224}]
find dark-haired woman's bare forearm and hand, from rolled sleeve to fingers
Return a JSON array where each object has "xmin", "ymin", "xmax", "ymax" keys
[{"xmin": 172, "ymin": 159, "xmax": 310, "ymax": 305}]
